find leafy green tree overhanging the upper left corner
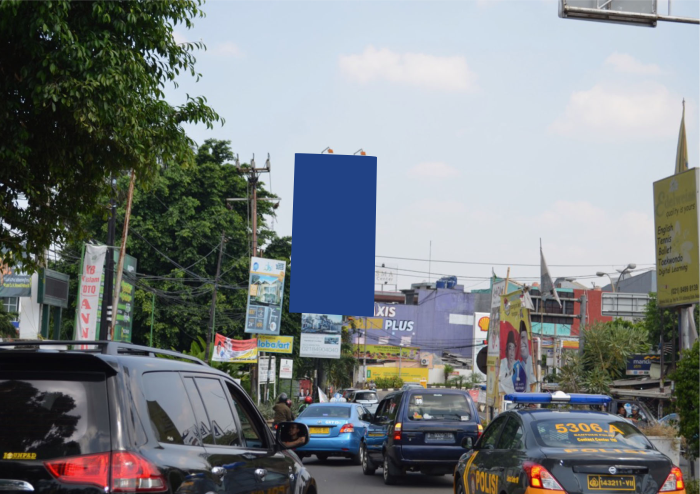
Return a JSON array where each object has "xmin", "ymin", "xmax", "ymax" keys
[{"xmin": 0, "ymin": 0, "xmax": 219, "ymax": 268}]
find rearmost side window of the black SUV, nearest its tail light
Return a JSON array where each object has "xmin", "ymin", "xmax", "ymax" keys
[{"xmin": 143, "ymin": 372, "xmax": 201, "ymax": 446}]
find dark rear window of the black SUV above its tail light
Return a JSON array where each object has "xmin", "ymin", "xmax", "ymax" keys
[{"xmin": 0, "ymin": 373, "xmax": 110, "ymax": 460}]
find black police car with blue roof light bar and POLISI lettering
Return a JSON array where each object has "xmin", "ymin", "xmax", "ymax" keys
[{"xmin": 454, "ymin": 392, "xmax": 685, "ymax": 494}]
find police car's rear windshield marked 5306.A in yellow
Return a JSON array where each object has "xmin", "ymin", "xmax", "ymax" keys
[{"xmin": 532, "ymin": 417, "xmax": 653, "ymax": 449}]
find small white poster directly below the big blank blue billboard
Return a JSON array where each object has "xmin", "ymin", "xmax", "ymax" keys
[{"xmin": 299, "ymin": 314, "xmax": 343, "ymax": 358}]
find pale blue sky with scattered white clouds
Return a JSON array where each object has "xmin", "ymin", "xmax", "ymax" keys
[{"xmin": 167, "ymin": 0, "xmax": 700, "ymax": 289}]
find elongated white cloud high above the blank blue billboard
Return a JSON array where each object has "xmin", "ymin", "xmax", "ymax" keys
[{"xmin": 339, "ymin": 46, "xmax": 476, "ymax": 92}]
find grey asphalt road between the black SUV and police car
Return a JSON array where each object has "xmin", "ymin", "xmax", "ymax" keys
[{"xmin": 303, "ymin": 456, "xmax": 452, "ymax": 494}]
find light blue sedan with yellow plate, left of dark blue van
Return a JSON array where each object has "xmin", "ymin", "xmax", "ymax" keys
[{"xmin": 295, "ymin": 403, "xmax": 371, "ymax": 465}]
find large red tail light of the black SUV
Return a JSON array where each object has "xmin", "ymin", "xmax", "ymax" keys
[{"xmin": 44, "ymin": 451, "xmax": 167, "ymax": 492}]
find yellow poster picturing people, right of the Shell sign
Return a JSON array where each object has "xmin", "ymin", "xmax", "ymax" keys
[{"xmin": 498, "ymin": 290, "xmax": 536, "ymax": 394}]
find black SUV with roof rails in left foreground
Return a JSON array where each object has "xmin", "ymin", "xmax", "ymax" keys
[{"xmin": 0, "ymin": 341, "xmax": 317, "ymax": 494}]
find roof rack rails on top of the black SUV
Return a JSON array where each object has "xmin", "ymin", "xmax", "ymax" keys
[{"xmin": 0, "ymin": 340, "xmax": 207, "ymax": 366}]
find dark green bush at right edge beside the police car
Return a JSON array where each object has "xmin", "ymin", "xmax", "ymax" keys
[{"xmin": 671, "ymin": 341, "xmax": 700, "ymax": 458}]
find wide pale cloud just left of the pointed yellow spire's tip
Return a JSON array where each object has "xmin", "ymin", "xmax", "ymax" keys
[{"xmin": 549, "ymin": 82, "xmax": 681, "ymax": 142}]
